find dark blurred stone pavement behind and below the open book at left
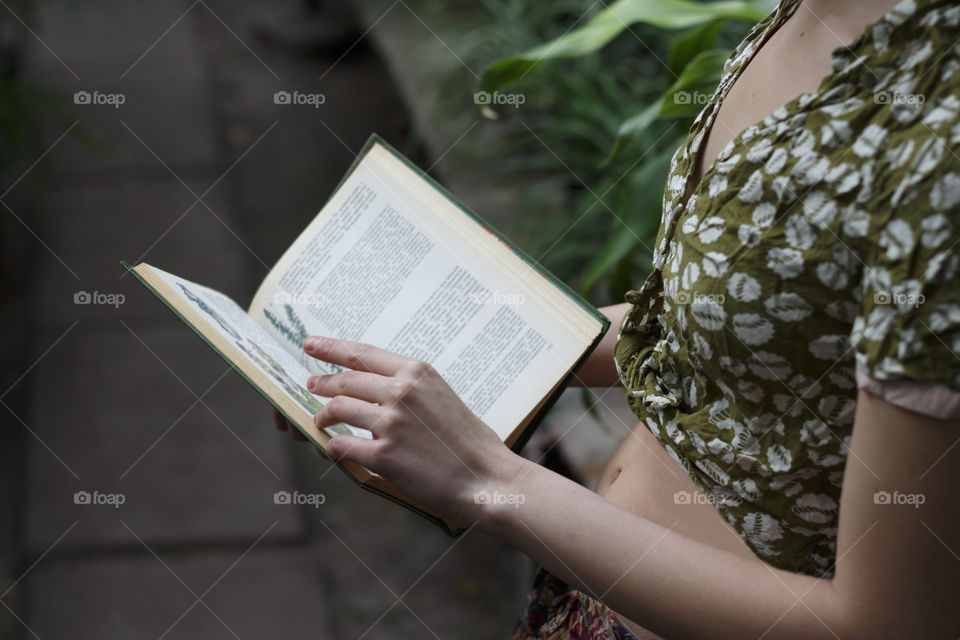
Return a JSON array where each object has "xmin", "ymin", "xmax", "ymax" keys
[{"xmin": 0, "ymin": 0, "xmax": 630, "ymax": 639}]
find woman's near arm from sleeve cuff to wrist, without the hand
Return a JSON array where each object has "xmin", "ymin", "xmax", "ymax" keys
[{"xmin": 484, "ymin": 393, "xmax": 960, "ymax": 639}]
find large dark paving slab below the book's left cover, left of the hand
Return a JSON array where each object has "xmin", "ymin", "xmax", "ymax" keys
[{"xmin": 24, "ymin": 325, "xmax": 302, "ymax": 552}]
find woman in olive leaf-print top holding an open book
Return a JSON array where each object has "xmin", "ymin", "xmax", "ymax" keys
[{"xmin": 270, "ymin": 0, "xmax": 960, "ymax": 640}]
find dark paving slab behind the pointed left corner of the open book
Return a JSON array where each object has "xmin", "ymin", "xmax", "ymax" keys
[{"xmin": 33, "ymin": 174, "xmax": 266, "ymax": 332}]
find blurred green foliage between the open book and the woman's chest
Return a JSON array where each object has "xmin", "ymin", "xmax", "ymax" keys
[{"xmin": 423, "ymin": 0, "xmax": 776, "ymax": 304}]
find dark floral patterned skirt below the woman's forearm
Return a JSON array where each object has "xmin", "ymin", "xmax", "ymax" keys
[{"xmin": 512, "ymin": 569, "xmax": 637, "ymax": 640}]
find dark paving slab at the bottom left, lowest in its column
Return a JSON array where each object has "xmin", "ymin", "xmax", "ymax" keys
[{"xmin": 28, "ymin": 548, "xmax": 336, "ymax": 640}]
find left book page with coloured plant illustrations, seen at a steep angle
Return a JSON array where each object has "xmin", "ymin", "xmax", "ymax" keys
[{"xmin": 150, "ymin": 267, "xmax": 372, "ymax": 438}]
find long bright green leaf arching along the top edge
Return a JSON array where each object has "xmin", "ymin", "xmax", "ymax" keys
[{"xmin": 479, "ymin": 0, "xmax": 770, "ymax": 92}]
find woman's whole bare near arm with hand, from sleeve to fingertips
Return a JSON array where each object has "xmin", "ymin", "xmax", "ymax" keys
[{"xmin": 307, "ymin": 339, "xmax": 960, "ymax": 640}]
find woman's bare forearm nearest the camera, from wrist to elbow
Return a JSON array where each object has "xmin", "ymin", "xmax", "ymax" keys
[{"xmin": 475, "ymin": 452, "xmax": 846, "ymax": 640}]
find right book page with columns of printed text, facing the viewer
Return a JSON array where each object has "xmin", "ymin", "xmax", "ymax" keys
[{"xmin": 249, "ymin": 142, "xmax": 600, "ymax": 439}]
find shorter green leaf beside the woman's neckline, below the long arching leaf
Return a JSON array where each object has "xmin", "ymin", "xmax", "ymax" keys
[{"xmin": 604, "ymin": 49, "xmax": 729, "ymax": 163}]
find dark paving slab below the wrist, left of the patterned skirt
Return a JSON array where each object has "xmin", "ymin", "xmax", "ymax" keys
[{"xmin": 294, "ymin": 445, "xmax": 530, "ymax": 640}]
